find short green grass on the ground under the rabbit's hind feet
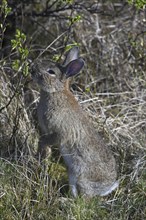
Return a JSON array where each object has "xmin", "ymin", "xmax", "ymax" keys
[{"xmin": 0, "ymin": 155, "xmax": 146, "ymax": 220}]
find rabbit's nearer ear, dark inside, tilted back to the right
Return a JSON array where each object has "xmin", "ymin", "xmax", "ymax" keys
[{"xmin": 65, "ymin": 58, "xmax": 84, "ymax": 78}]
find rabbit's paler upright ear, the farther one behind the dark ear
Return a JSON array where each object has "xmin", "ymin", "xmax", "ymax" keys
[{"xmin": 63, "ymin": 47, "xmax": 79, "ymax": 66}]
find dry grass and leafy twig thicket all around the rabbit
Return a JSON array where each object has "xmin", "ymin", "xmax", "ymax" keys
[{"xmin": 0, "ymin": 0, "xmax": 146, "ymax": 220}]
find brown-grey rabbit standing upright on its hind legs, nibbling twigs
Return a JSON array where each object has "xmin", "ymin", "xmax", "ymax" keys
[{"xmin": 32, "ymin": 47, "xmax": 119, "ymax": 197}]
